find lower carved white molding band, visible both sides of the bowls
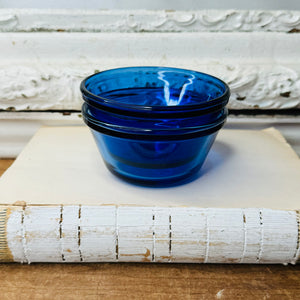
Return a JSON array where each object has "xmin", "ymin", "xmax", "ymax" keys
[{"xmin": 0, "ymin": 64, "xmax": 300, "ymax": 111}]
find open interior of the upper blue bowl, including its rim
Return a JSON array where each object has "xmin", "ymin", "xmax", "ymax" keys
[{"xmin": 81, "ymin": 67, "xmax": 229, "ymax": 111}]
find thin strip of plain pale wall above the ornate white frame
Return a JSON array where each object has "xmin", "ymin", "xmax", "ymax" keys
[{"xmin": 0, "ymin": 0, "xmax": 300, "ymax": 10}]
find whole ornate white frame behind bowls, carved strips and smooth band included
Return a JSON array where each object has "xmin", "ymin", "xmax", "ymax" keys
[{"xmin": 0, "ymin": 9, "xmax": 300, "ymax": 111}]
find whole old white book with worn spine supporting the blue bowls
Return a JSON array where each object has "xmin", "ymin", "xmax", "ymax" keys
[{"xmin": 0, "ymin": 126, "xmax": 300, "ymax": 264}]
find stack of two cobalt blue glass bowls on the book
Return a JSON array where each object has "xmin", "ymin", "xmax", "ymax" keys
[{"xmin": 80, "ymin": 67, "xmax": 230, "ymax": 186}]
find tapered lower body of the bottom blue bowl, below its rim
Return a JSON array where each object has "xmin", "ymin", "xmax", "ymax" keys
[{"xmin": 92, "ymin": 130, "xmax": 217, "ymax": 187}]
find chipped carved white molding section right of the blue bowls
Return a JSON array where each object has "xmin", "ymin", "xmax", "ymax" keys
[{"xmin": 226, "ymin": 65, "xmax": 300, "ymax": 109}]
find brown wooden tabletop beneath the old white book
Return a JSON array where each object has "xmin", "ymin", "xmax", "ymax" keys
[{"xmin": 0, "ymin": 160, "xmax": 300, "ymax": 300}]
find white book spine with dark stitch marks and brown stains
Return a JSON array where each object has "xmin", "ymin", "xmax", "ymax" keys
[{"xmin": 1, "ymin": 205, "xmax": 299, "ymax": 264}]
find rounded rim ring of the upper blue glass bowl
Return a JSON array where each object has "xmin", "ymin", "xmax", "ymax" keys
[{"xmin": 80, "ymin": 66, "xmax": 230, "ymax": 114}]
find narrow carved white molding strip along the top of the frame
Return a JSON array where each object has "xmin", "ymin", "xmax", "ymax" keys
[{"xmin": 0, "ymin": 9, "xmax": 300, "ymax": 32}]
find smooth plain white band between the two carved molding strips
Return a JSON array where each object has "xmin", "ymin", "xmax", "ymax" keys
[{"xmin": 0, "ymin": 32, "xmax": 300, "ymax": 63}]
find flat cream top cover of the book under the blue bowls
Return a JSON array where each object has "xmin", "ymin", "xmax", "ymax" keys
[{"xmin": 0, "ymin": 127, "xmax": 300, "ymax": 209}]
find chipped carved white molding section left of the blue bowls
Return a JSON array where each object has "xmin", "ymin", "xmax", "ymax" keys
[{"xmin": 0, "ymin": 64, "xmax": 89, "ymax": 111}]
